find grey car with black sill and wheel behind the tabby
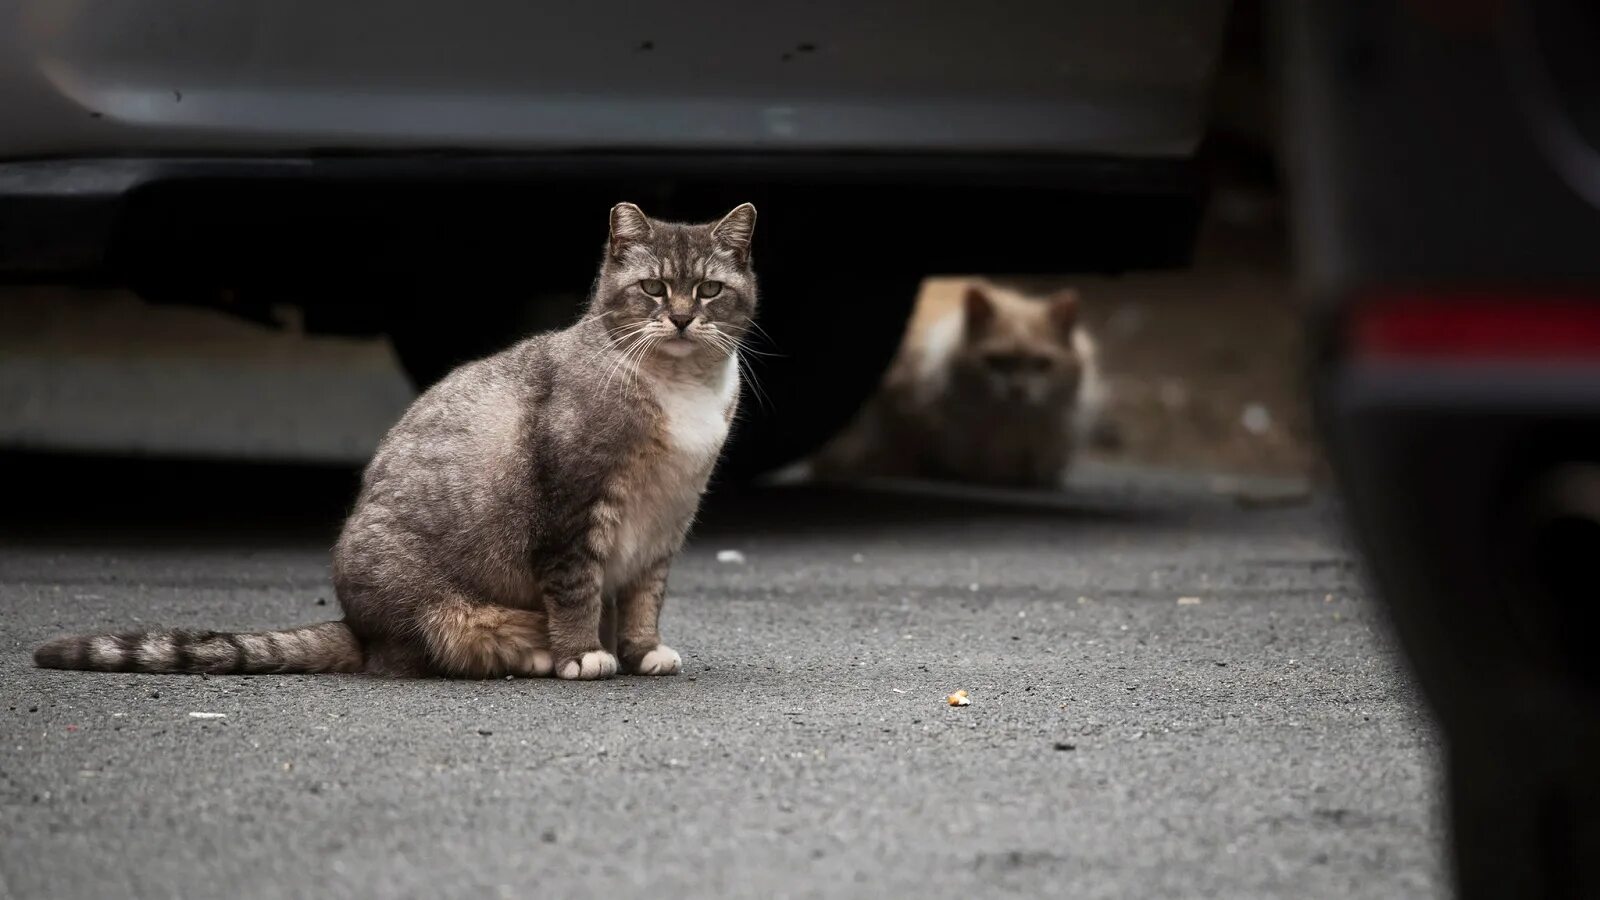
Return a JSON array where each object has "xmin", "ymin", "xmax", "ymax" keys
[{"xmin": 0, "ymin": 0, "xmax": 1227, "ymax": 471}]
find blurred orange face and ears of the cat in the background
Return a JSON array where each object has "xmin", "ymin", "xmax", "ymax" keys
[{"xmin": 952, "ymin": 287, "xmax": 1083, "ymax": 407}]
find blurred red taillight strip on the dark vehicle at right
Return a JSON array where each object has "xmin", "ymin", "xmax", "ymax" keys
[{"xmin": 1349, "ymin": 293, "xmax": 1600, "ymax": 362}]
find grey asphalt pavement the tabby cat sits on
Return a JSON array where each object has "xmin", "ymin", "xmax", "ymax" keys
[{"xmin": 0, "ymin": 460, "xmax": 1445, "ymax": 898}]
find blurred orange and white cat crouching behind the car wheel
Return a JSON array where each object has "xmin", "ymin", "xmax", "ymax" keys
[{"xmin": 813, "ymin": 279, "xmax": 1104, "ymax": 487}]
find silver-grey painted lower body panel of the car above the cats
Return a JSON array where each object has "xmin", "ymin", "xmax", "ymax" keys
[{"xmin": 0, "ymin": 0, "xmax": 1227, "ymax": 160}]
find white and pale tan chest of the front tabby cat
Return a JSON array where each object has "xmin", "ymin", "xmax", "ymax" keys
[{"xmin": 605, "ymin": 359, "xmax": 739, "ymax": 589}]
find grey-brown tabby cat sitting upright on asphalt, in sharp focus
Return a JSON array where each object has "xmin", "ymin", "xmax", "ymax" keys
[{"xmin": 34, "ymin": 203, "xmax": 755, "ymax": 679}]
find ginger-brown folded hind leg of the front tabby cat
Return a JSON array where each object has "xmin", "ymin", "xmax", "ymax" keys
[{"xmin": 416, "ymin": 596, "xmax": 554, "ymax": 677}]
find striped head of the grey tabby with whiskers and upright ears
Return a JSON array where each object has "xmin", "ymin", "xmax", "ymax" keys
[{"xmin": 592, "ymin": 203, "xmax": 755, "ymax": 359}]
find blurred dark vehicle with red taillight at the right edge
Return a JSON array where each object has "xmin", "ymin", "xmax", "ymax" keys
[{"xmin": 1283, "ymin": 0, "xmax": 1600, "ymax": 897}]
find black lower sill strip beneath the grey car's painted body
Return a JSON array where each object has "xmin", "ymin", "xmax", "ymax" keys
[{"xmin": 0, "ymin": 154, "xmax": 1202, "ymax": 287}]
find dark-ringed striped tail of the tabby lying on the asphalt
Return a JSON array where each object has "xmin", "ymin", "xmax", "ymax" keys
[{"xmin": 34, "ymin": 621, "xmax": 362, "ymax": 674}]
